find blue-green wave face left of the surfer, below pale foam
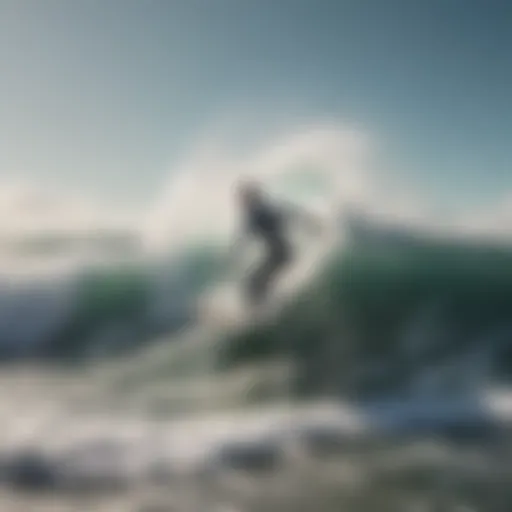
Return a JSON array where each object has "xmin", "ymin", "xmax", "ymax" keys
[{"xmin": 0, "ymin": 247, "xmax": 221, "ymax": 359}]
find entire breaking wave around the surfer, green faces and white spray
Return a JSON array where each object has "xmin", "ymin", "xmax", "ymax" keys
[{"xmin": 0, "ymin": 123, "xmax": 512, "ymax": 404}]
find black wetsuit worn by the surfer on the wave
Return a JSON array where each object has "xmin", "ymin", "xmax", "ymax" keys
[{"xmin": 245, "ymin": 201, "xmax": 292, "ymax": 305}]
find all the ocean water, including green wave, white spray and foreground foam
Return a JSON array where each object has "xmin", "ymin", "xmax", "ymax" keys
[{"xmin": 0, "ymin": 130, "xmax": 512, "ymax": 512}]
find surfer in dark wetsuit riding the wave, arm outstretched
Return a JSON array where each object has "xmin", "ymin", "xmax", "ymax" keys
[{"xmin": 236, "ymin": 182, "xmax": 318, "ymax": 307}]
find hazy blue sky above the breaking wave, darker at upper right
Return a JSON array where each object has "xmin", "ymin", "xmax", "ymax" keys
[{"xmin": 0, "ymin": 0, "xmax": 512, "ymax": 211}]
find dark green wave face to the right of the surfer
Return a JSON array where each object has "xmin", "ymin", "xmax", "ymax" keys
[{"xmin": 221, "ymin": 218, "xmax": 512, "ymax": 398}]
